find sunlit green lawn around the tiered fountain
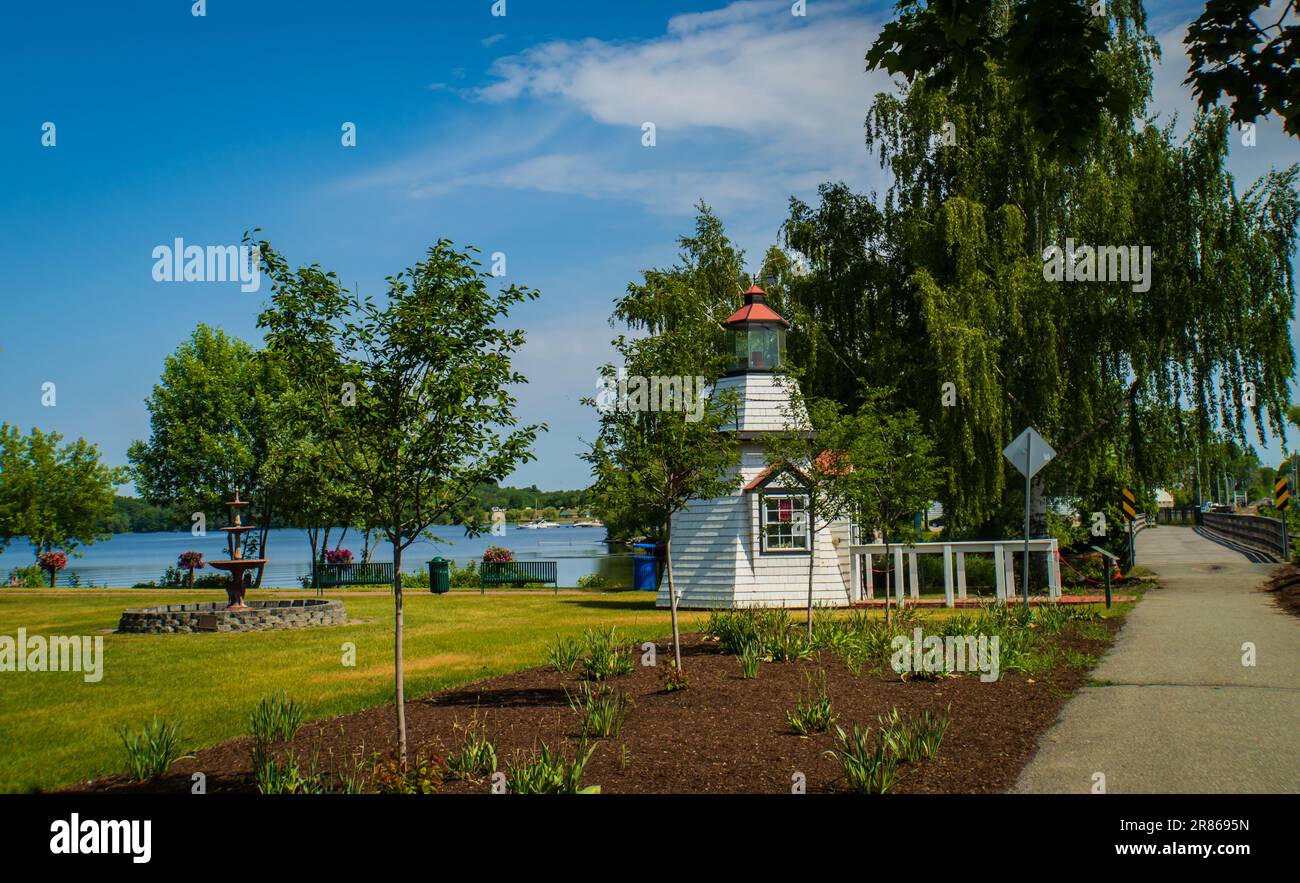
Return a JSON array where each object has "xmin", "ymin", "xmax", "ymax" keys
[{"xmin": 0, "ymin": 589, "xmax": 703, "ymax": 792}]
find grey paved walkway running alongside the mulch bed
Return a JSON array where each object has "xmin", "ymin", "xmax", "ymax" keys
[{"xmin": 1014, "ymin": 527, "xmax": 1300, "ymax": 793}]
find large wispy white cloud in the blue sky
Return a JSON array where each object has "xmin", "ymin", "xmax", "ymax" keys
[{"xmin": 345, "ymin": 0, "xmax": 889, "ymax": 213}]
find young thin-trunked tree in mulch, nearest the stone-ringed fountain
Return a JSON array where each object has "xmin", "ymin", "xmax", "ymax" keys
[{"xmin": 256, "ymin": 239, "xmax": 545, "ymax": 763}]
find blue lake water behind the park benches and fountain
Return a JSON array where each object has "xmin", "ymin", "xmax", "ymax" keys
[{"xmin": 0, "ymin": 524, "xmax": 632, "ymax": 588}]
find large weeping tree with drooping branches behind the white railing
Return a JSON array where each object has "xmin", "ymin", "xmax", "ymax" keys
[{"xmin": 783, "ymin": 0, "xmax": 1300, "ymax": 546}]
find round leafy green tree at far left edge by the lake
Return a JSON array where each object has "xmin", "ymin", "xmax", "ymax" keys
[{"xmin": 0, "ymin": 423, "xmax": 126, "ymax": 555}]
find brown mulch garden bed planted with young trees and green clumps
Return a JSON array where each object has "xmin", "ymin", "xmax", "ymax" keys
[{"xmin": 74, "ymin": 619, "xmax": 1119, "ymax": 793}]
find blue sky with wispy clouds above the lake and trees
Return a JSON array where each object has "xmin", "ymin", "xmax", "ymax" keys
[{"xmin": 0, "ymin": 0, "xmax": 1300, "ymax": 489}]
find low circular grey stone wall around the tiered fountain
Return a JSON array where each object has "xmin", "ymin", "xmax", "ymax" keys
[{"xmin": 117, "ymin": 598, "xmax": 347, "ymax": 635}]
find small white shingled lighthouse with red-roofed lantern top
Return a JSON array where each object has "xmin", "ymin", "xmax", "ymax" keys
[{"xmin": 657, "ymin": 286, "xmax": 850, "ymax": 607}]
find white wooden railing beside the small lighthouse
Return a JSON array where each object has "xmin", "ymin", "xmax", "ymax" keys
[{"xmin": 849, "ymin": 538, "xmax": 1061, "ymax": 607}]
